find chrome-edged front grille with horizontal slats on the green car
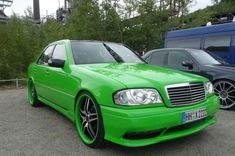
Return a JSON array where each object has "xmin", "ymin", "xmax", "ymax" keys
[{"xmin": 166, "ymin": 83, "xmax": 206, "ymax": 106}]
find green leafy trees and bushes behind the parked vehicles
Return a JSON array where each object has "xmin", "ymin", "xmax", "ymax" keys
[{"xmin": 0, "ymin": 0, "xmax": 235, "ymax": 79}]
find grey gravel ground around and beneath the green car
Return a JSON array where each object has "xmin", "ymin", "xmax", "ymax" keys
[{"xmin": 0, "ymin": 89, "xmax": 235, "ymax": 156}]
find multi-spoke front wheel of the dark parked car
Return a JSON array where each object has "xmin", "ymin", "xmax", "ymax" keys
[{"xmin": 214, "ymin": 80, "xmax": 235, "ymax": 110}]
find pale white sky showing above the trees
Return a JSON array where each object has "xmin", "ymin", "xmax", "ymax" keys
[{"xmin": 5, "ymin": 0, "xmax": 211, "ymax": 16}]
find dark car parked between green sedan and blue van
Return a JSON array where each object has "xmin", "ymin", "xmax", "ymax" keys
[{"xmin": 143, "ymin": 48, "xmax": 235, "ymax": 109}]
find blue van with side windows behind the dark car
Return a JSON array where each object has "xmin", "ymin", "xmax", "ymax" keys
[{"xmin": 164, "ymin": 22, "xmax": 235, "ymax": 64}]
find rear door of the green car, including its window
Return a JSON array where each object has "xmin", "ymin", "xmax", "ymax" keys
[{"xmin": 33, "ymin": 45, "xmax": 54, "ymax": 99}]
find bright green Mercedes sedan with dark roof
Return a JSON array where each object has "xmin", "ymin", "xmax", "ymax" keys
[{"xmin": 28, "ymin": 40, "xmax": 219, "ymax": 148}]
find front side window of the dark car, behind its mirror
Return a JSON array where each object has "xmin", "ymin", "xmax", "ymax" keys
[{"xmin": 167, "ymin": 50, "xmax": 198, "ymax": 73}]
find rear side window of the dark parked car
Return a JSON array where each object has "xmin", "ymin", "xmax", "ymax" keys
[{"xmin": 150, "ymin": 51, "xmax": 167, "ymax": 66}]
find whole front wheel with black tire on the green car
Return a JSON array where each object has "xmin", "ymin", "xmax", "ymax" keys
[{"xmin": 75, "ymin": 92, "xmax": 104, "ymax": 148}]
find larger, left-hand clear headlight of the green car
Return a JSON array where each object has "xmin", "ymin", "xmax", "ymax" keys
[{"xmin": 114, "ymin": 89, "xmax": 162, "ymax": 105}]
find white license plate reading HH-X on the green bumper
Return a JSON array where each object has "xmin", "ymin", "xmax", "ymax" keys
[{"xmin": 182, "ymin": 109, "xmax": 207, "ymax": 123}]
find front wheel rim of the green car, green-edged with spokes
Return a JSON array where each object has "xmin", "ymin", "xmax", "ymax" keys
[{"xmin": 75, "ymin": 94, "xmax": 99, "ymax": 144}]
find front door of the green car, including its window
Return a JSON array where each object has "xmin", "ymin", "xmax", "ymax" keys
[{"xmin": 47, "ymin": 44, "xmax": 73, "ymax": 109}]
